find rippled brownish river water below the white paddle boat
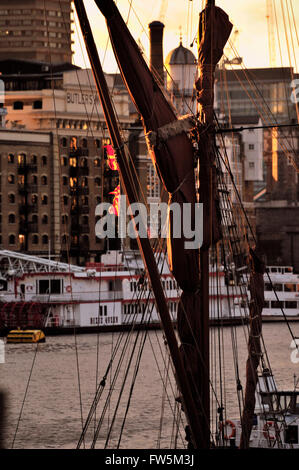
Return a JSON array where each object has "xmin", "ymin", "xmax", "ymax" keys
[{"xmin": 0, "ymin": 323, "xmax": 299, "ymax": 449}]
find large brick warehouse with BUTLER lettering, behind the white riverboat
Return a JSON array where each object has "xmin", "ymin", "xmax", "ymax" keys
[{"xmin": 0, "ymin": 60, "xmax": 132, "ymax": 264}]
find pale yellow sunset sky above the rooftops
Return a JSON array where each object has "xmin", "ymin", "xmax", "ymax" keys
[{"xmin": 74, "ymin": 0, "xmax": 299, "ymax": 73}]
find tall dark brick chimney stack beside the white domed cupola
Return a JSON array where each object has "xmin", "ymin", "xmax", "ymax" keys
[{"xmin": 149, "ymin": 21, "xmax": 164, "ymax": 87}]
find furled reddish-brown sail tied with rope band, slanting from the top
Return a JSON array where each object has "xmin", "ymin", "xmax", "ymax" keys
[{"xmin": 96, "ymin": 0, "xmax": 199, "ymax": 290}]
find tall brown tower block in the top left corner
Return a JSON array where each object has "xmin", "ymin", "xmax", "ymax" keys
[{"xmin": 0, "ymin": 0, "xmax": 72, "ymax": 64}]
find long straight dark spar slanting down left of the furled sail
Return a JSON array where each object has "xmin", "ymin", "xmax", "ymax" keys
[{"xmin": 74, "ymin": 0, "xmax": 205, "ymax": 448}]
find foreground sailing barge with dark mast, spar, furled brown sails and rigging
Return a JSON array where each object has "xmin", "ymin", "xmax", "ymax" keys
[{"xmin": 69, "ymin": 0, "xmax": 298, "ymax": 449}]
